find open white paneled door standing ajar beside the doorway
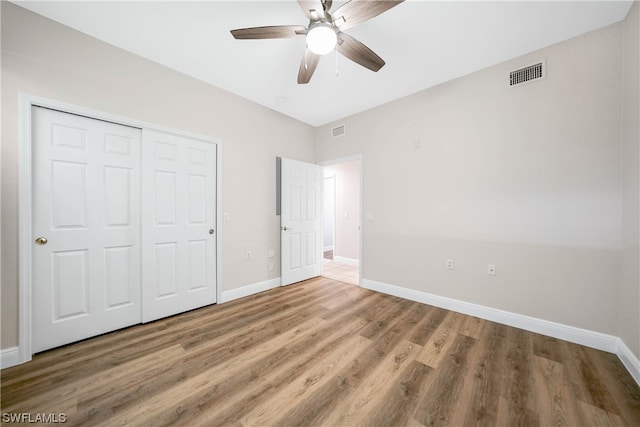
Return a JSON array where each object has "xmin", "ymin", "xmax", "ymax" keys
[{"xmin": 280, "ymin": 159, "xmax": 323, "ymax": 286}]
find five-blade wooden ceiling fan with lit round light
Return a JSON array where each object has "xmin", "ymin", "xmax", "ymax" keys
[{"xmin": 231, "ymin": 0, "xmax": 404, "ymax": 84}]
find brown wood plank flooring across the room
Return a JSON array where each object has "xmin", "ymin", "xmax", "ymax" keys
[{"xmin": 1, "ymin": 278, "xmax": 640, "ymax": 427}]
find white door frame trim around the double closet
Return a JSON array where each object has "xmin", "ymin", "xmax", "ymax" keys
[{"xmin": 16, "ymin": 93, "xmax": 223, "ymax": 368}]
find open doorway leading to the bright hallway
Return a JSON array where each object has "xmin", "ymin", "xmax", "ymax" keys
[{"xmin": 323, "ymin": 158, "xmax": 362, "ymax": 285}]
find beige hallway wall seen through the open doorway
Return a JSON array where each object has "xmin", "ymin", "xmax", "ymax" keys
[{"xmin": 324, "ymin": 160, "xmax": 360, "ymax": 260}]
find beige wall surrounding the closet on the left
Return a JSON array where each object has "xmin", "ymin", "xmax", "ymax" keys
[{"xmin": 1, "ymin": 2, "xmax": 314, "ymax": 348}]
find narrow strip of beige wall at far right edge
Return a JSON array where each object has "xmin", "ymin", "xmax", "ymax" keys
[{"xmin": 620, "ymin": 1, "xmax": 640, "ymax": 358}]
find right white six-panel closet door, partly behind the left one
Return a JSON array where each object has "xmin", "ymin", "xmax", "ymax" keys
[{"xmin": 142, "ymin": 130, "xmax": 216, "ymax": 322}]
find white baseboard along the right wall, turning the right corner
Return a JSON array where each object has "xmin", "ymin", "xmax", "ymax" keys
[{"xmin": 361, "ymin": 279, "xmax": 640, "ymax": 385}]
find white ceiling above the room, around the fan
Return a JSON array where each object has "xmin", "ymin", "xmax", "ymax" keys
[{"xmin": 15, "ymin": 0, "xmax": 632, "ymax": 126}]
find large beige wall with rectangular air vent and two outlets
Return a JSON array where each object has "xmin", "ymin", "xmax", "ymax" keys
[{"xmin": 316, "ymin": 24, "xmax": 622, "ymax": 335}]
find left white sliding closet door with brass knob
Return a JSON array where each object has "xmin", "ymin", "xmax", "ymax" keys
[{"xmin": 32, "ymin": 107, "xmax": 141, "ymax": 352}]
